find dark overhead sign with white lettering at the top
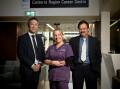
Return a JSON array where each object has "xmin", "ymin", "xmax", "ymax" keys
[{"xmin": 30, "ymin": 0, "xmax": 89, "ymax": 8}]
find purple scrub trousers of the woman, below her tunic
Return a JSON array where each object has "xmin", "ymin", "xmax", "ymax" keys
[{"xmin": 50, "ymin": 81, "xmax": 69, "ymax": 89}]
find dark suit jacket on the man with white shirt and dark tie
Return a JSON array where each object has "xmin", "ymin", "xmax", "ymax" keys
[{"xmin": 17, "ymin": 33, "xmax": 45, "ymax": 72}]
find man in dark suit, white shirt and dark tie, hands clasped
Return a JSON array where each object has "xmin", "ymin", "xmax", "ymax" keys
[{"xmin": 17, "ymin": 17, "xmax": 45, "ymax": 89}]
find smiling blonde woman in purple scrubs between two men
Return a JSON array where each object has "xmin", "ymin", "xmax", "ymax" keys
[{"xmin": 45, "ymin": 30, "xmax": 73, "ymax": 89}]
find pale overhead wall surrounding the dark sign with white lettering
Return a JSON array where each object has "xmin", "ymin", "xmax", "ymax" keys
[{"xmin": 0, "ymin": 0, "xmax": 99, "ymax": 16}]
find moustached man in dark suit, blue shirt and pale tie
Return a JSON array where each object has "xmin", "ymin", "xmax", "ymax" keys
[{"xmin": 69, "ymin": 20, "xmax": 101, "ymax": 89}]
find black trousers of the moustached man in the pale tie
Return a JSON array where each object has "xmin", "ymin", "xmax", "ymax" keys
[{"xmin": 72, "ymin": 64, "xmax": 97, "ymax": 89}]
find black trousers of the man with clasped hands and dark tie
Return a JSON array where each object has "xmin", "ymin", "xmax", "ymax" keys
[{"xmin": 21, "ymin": 68, "xmax": 40, "ymax": 89}]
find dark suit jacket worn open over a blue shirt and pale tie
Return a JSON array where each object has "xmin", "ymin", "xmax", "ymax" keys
[{"xmin": 69, "ymin": 36, "xmax": 101, "ymax": 72}]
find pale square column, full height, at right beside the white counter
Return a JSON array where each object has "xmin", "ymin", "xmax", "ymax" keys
[{"xmin": 101, "ymin": 11, "xmax": 111, "ymax": 89}]
